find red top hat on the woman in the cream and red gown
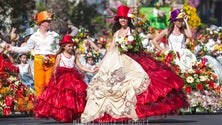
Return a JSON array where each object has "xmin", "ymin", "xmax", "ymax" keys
[{"xmin": 114, "ymin": 6, "xmax": 130, "ymax": 20}]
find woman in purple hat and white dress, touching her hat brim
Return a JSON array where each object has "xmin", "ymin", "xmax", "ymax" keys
[{"xmin": 153, "ymin": 9, "xmax": 196, "ymax": 71}]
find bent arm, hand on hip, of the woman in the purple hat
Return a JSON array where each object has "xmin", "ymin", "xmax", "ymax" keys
[{"xmin": 152, "ymin": 29, "xmax": 168, "ymax": 51}]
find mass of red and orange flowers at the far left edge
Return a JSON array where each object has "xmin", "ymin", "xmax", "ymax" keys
[{"xmin": 0, "ymin": 54, "xmax": 34, "ymax": 116}]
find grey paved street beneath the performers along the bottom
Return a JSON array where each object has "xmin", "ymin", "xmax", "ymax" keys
[{"xmin": 0, "ymin": 113, "xmax": 222, "ymax": 125}]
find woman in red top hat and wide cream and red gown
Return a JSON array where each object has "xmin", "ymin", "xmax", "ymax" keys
[{"xmin": 81, "ymin": 6, "xmax": 188, "ymax": 123}]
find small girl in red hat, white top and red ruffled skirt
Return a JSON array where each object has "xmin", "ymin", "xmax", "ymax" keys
[{"xmin": 34, "ymin": 35, "xmax": 96, "ymax": 122}]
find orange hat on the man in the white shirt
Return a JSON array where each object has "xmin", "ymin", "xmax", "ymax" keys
[{"xmin": 35, "ymin": 11, "xmax": 52, "ymax": 26}]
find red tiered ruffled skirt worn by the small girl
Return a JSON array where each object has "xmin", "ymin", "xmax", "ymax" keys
[{"xmin": 34, "ymin": 67, "xmax": 87, "ymax": 122}]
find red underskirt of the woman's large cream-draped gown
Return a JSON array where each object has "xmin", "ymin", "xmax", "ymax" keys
[{"xmin": 94, "ymin": 52, "xmax": 189, "ymax": 122}]
